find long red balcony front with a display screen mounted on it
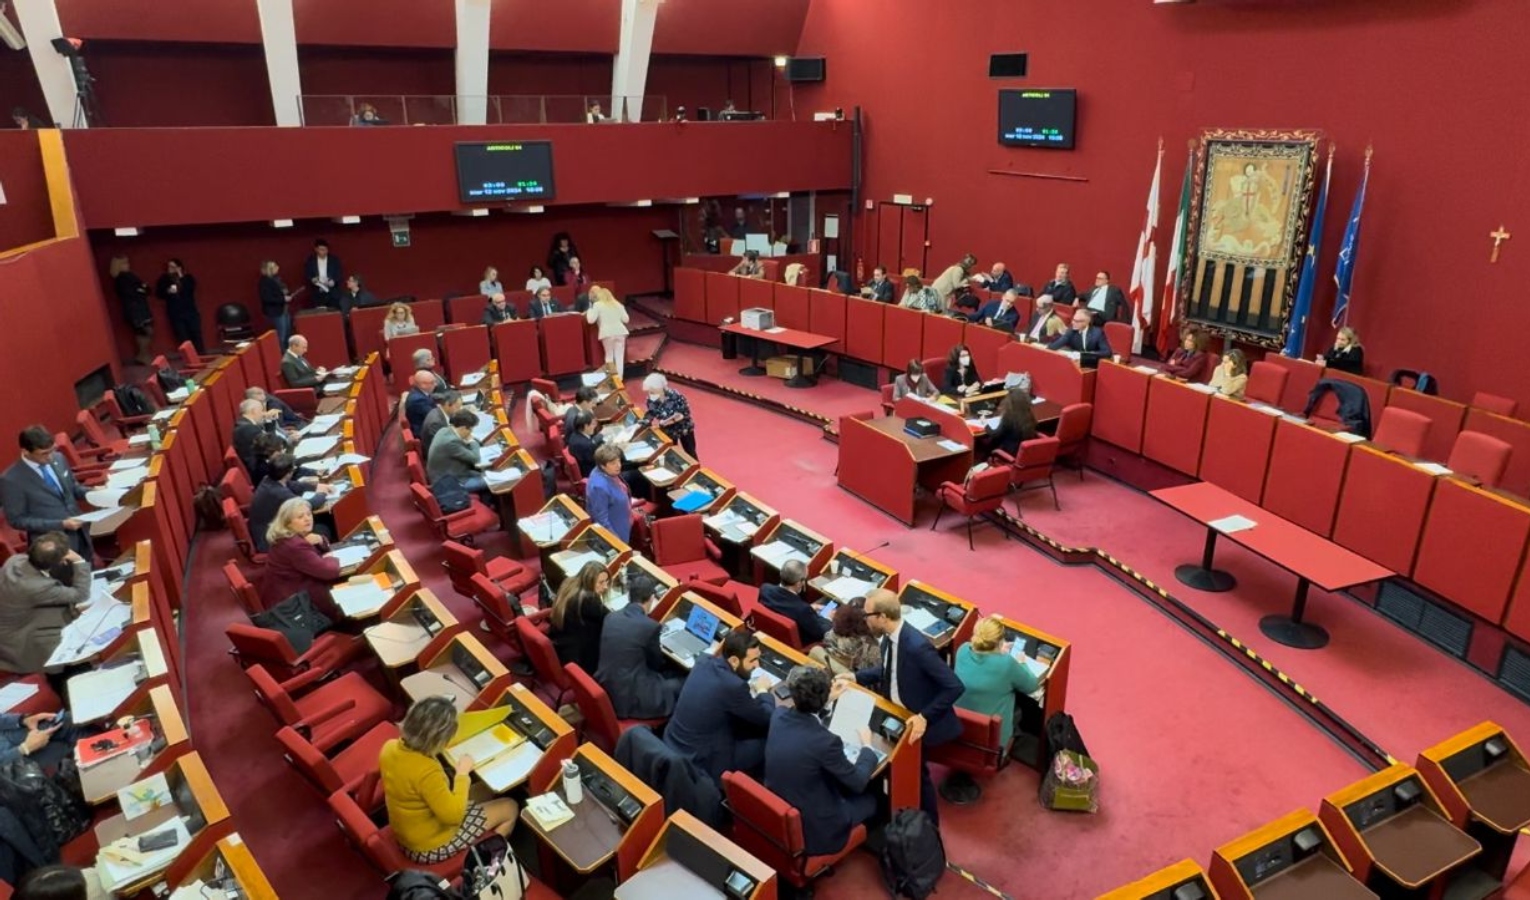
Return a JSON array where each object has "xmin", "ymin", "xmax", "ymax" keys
[{"xmin": 66, "ymin": 122, "xmax": 851, "ymax": 228}]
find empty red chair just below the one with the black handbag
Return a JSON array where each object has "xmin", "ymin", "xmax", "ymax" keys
[{"xmin": 245, "ymin": 666, "xmax": 393, "ymax": 747}]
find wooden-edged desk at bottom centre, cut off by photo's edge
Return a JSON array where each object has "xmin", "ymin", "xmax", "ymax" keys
[{"xmin": 615, "ymin": 810, "xmax": 776, "ymax": 900}]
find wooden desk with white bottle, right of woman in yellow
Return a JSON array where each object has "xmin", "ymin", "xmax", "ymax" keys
[{"xmin": 520, "ymin": 744, "xmax": 664, "ymax": 877}]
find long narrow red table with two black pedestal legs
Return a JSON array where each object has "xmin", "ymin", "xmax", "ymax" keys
[{"xmin": 1152, "ymin": 482, "xmax": 1394, "ymax": 651}]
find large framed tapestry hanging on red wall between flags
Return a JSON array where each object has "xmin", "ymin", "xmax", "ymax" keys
[{"xmin": 1180, "ymin": 130, "xmax": 1322, "ymax": 347}]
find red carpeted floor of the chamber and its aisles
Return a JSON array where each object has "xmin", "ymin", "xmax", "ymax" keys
[{"xmin": 185, "ymin": 343, "xmax": 1530, "ymax": 900}]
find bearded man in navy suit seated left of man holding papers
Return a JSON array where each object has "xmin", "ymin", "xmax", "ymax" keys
[{"xmin": 664, "ymin": 628, "xmax": 777, "ymax": 782}]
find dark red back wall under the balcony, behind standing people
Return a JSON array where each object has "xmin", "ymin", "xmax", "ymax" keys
[{"xmin": 90, "ymin": 207, "xmax": 679, "ymax": 355}]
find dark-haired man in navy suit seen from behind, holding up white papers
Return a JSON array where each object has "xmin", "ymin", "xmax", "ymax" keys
[{"xmin": 765, "ymin": 666, "xmax": 877, "ymax": 856}]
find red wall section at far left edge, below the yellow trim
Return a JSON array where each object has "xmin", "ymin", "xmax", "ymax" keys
[{"xmin": 0, "ymin": 235, "xmax": 116, "ymax": 440}]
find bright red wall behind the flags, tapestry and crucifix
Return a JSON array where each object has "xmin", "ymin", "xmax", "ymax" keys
[{"xmin": 801, "ymin": 0, "xmax": 1530, "ymax": 401}]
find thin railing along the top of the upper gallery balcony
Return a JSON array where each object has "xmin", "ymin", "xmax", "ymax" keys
[{"xmin": 298, "ymin": 93, "xmax": 669, "ymax": 127}]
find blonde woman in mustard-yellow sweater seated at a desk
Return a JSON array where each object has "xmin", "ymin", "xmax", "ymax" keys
[{"xmin": 378, "ymin": 696, "xmax": 520, "ymax": 865}]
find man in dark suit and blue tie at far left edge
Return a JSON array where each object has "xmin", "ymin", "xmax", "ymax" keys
[{"xmin": 0, "ymin": 426, "xmax": 93, "ymax": 560}]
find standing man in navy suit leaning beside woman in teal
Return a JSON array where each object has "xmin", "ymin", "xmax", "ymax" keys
[{"xmin": 840, "ymin": 589, "xmax": 965, "ymax": 825}]
